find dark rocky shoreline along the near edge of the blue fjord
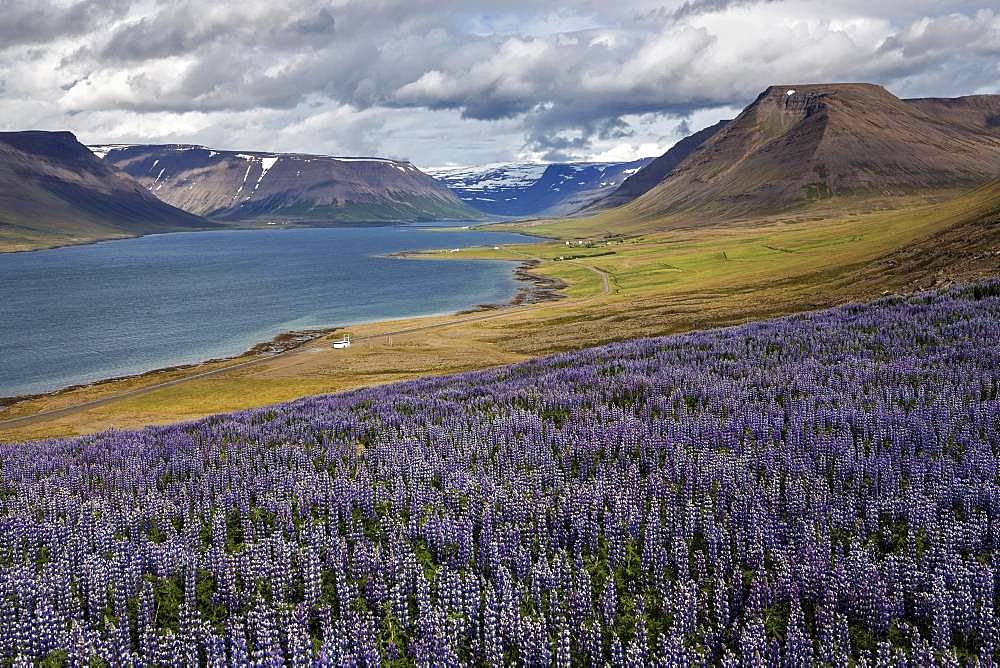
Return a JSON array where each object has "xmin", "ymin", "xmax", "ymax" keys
[{"xmin": 0, "ymin": 256, "xmax": 567, "ymax": 418}]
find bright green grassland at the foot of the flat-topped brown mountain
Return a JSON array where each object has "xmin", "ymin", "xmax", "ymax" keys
[{"xmin": 468, "ymin": 181, "xmax": 1000, "ymax": 296}]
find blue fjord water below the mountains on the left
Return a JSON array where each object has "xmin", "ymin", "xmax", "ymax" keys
[{"xmin": 0, "ymin": 226, "xmax": 526, "ymax": 396}]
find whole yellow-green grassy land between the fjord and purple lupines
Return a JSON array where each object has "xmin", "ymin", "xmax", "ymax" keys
[{"xmin": 0, "ymin": 180, "xmax": 1000, "ymax": 441}]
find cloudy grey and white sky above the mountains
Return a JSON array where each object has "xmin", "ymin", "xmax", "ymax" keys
[{"xmin": 0, "ymin": 0, "xmax": 1000, "ymax": 167}]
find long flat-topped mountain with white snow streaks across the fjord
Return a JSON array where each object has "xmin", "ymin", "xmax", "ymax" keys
[{"xmin": 91, "ymin": 144, "xmax": 482, "ymax": 223}]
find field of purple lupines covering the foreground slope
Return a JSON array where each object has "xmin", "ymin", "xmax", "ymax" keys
[{"xmin": 0, "ymin": 283, "xmax": 1000, "ymax": 666}]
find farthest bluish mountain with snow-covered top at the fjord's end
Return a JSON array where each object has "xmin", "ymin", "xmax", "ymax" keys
[{"xmin": 427, "ymin": 158, "xmax": 652, "ymax": 218}]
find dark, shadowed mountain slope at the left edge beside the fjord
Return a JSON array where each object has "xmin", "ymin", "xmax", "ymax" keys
[{"xmin": 0, "ymin": 130, "xmax": 214, "ymax": 250}]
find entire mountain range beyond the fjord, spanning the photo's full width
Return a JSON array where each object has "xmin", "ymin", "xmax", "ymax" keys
[{"xmin": 0, "ymin": 84, "xmax": 1000, "ymax": 250}]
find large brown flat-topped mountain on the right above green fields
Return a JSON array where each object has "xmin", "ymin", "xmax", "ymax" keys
[{"xmin": 623, "ymin": 84, "xmax": 1000, "ymax": 218}]
